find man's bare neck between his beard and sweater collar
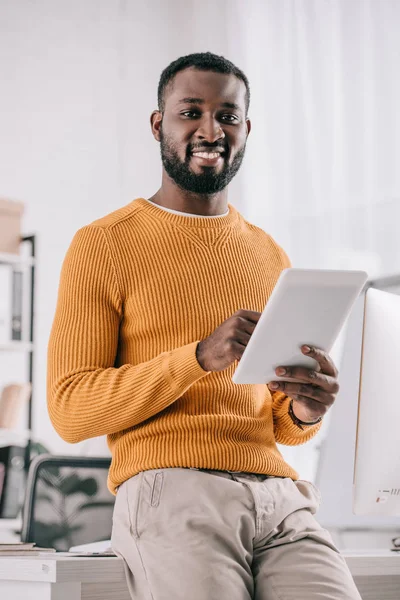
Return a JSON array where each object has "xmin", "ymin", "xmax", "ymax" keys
[{"xmin": 149, "ymin": 173, "xmax": 228, "ymax": 216}]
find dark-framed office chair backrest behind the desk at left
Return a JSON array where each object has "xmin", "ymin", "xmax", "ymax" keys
[{"xmin": 21, "ymin": 454, "xmax": 115, "ymax": 551}]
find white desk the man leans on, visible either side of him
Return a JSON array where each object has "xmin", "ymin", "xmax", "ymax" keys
[{"xmin": 0, "ymin": 551, "xmax": 400, "ymax": 600}]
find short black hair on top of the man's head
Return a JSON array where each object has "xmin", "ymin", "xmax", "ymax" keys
[{"xmin": 157, "ymin": 52, "xmax": 250, "ymax": 115}]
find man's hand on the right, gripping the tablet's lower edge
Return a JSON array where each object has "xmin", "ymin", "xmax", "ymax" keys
[{"xmin": 268, "ymin": 346, "xmax": 339, "ymax": 423}]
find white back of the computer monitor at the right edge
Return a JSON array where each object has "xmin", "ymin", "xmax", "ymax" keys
[{"xmin": 353, "ymin": 288, "xmax": 400, "ymax": 516}]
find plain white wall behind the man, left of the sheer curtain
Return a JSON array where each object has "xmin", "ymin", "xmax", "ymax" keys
[{"xmin": 0, "ymin": 0, "xmax": 245, "ymax": 453}]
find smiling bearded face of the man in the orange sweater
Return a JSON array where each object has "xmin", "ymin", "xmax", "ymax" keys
[{"xmin": 155, "ymin": 68, "xmax": 250, "ymax": 194}]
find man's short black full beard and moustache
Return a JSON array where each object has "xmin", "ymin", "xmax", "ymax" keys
[{"xmin": 160, "ymin": 128, "xmax": 246, "ymax": 195}]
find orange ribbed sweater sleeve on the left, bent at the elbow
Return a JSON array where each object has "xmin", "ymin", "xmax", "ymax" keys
[{"xmin": 47, "ymin": 225, "xmax": 207, "ymax": 443}]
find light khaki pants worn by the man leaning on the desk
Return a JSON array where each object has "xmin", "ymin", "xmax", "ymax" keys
[{"xmin": 112, "ymin": 468, "xmax": 361, "ymax": 600}]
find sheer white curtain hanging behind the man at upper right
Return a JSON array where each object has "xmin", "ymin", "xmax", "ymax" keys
[{"xmin": 231, "ymin": 0, "xmax": 400, "ymax": 277}]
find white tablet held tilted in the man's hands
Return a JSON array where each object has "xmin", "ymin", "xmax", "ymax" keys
[{"xmin": 232, "ymin": 268, "xmax": 368, "ymax": 383}]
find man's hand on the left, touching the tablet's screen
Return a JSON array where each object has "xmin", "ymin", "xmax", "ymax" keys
[{"xmin": 196, "ymin": 308, "xmax": 261, "ymax": 371}]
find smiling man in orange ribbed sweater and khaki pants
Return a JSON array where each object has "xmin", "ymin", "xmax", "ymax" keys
[{"xmin": 48, "ymin": 53, "xmax": 360, "ymax": 600}]
